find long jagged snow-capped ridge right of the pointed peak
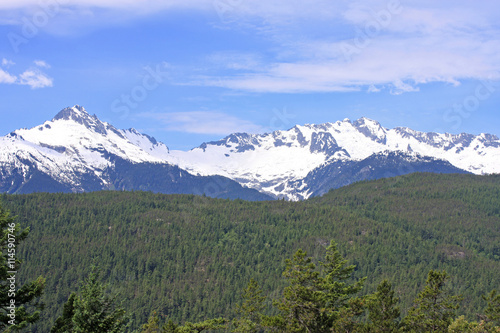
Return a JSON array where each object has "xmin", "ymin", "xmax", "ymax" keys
[{"xmin": 169, "ymin": 118, "xmax": 500, "ymax": 200}]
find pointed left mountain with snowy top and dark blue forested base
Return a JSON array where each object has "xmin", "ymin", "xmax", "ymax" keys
[{"xmin": 0, "ymin": 106, "xmax": 270, "ymax": 200}]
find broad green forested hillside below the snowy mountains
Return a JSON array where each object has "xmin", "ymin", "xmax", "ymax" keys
[{"xmin": 0, "ymin": 174, "xmax": 500, "ymax": 332}]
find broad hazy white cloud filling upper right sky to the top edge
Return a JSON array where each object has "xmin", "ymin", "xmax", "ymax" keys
[{"xmin": 193, "ymin": 0, "xmax": 500, "ymax": 94}]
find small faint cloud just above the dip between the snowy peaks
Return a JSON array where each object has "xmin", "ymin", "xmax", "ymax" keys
[{"xmin": 139, "ymin": 111, "xmax": 262, "ymax": 135}]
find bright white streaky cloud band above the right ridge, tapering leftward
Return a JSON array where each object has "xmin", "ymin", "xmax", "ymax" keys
[{"xmin": 198, "ymin": 32, "xmax": 500, "ymax": 94}]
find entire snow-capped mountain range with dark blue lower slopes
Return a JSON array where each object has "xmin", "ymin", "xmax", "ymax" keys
[{"xmin": 0, "ymin": 105, "xmax": 500, "ymax": 200}]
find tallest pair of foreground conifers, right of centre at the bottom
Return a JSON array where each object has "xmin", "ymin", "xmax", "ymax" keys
[{"xmin": 265, "ymin": 242, "xmax": 364, "ymax": 332}]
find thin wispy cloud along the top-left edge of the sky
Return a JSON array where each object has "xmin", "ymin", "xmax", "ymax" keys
[{"xmin": 0, "ymin": 0, "xmax": 212, "ymax": 37}]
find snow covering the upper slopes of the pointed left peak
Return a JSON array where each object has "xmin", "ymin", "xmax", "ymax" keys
[{"xmin": 0, "ymin": 106, "xmax": 169, "ymax": 191}]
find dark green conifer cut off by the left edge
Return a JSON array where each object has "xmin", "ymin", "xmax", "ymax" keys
[{"xmin": 0, "ymin": 202, "xmax": 45, "ymax": 332}]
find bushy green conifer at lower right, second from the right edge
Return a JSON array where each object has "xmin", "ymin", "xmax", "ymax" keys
[{"xmin": 403, "ymin": 270, "xmax": 461, "ymax": 333}]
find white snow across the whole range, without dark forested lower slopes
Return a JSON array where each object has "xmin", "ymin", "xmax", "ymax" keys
[{"xmin": 0, "ymin": 106, "xmax": 500, "ymax": 200}]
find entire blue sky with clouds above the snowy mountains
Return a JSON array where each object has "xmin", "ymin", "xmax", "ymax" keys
[{"xmin": 0, "ymin": 0, "xmax": 500, "ymax": 150}]
